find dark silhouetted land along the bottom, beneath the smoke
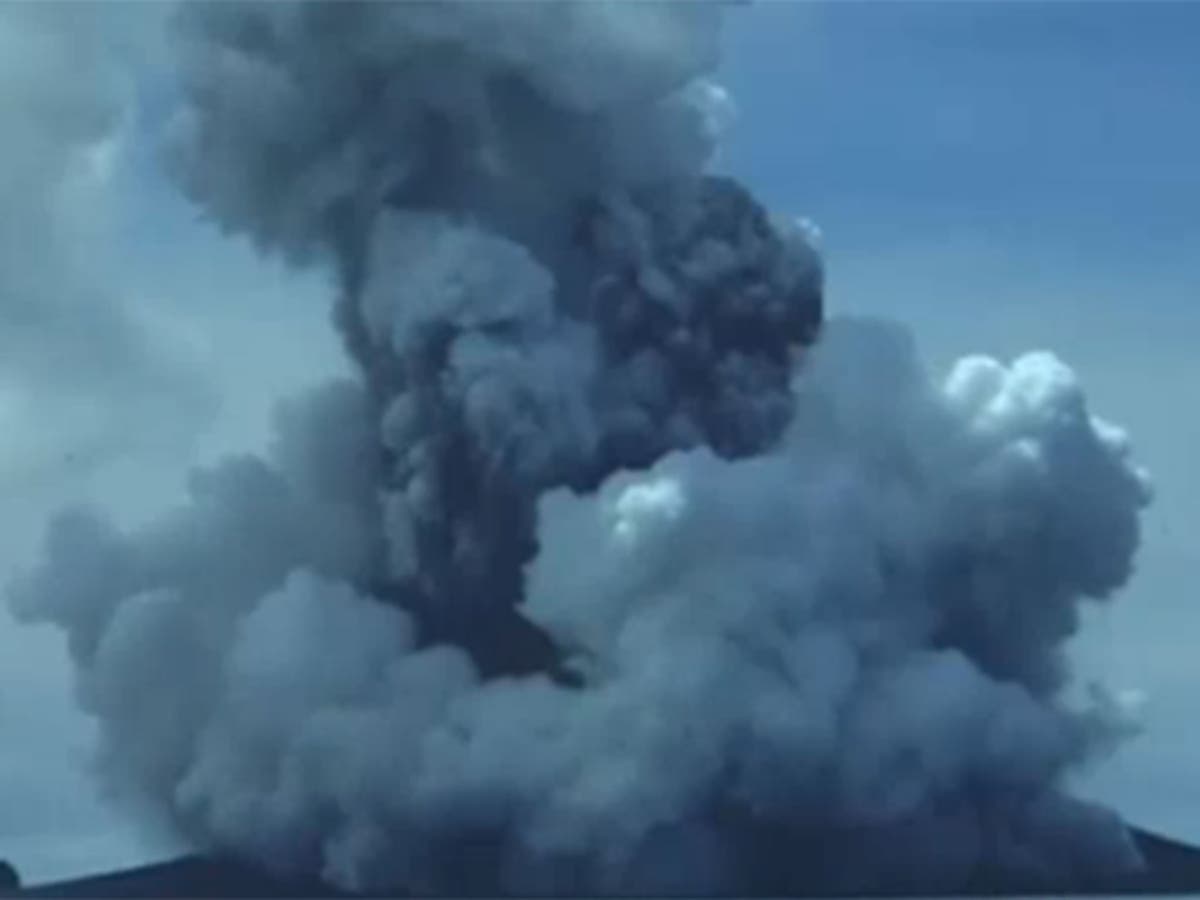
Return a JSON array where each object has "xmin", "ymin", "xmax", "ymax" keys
[{"xmin": 7, "ymin": 829, "xmax": 1200, "ymax": 898}]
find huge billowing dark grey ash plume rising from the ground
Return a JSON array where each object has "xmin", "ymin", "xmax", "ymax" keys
[{"xmin": 12, "ymin": 2, "xmax": 1148, "ymax": 893}]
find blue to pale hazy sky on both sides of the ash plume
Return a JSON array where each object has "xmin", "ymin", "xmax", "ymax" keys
[{"xmin": 0, "ymin": 0, "xmax": 1200, "ymax": 878}]
